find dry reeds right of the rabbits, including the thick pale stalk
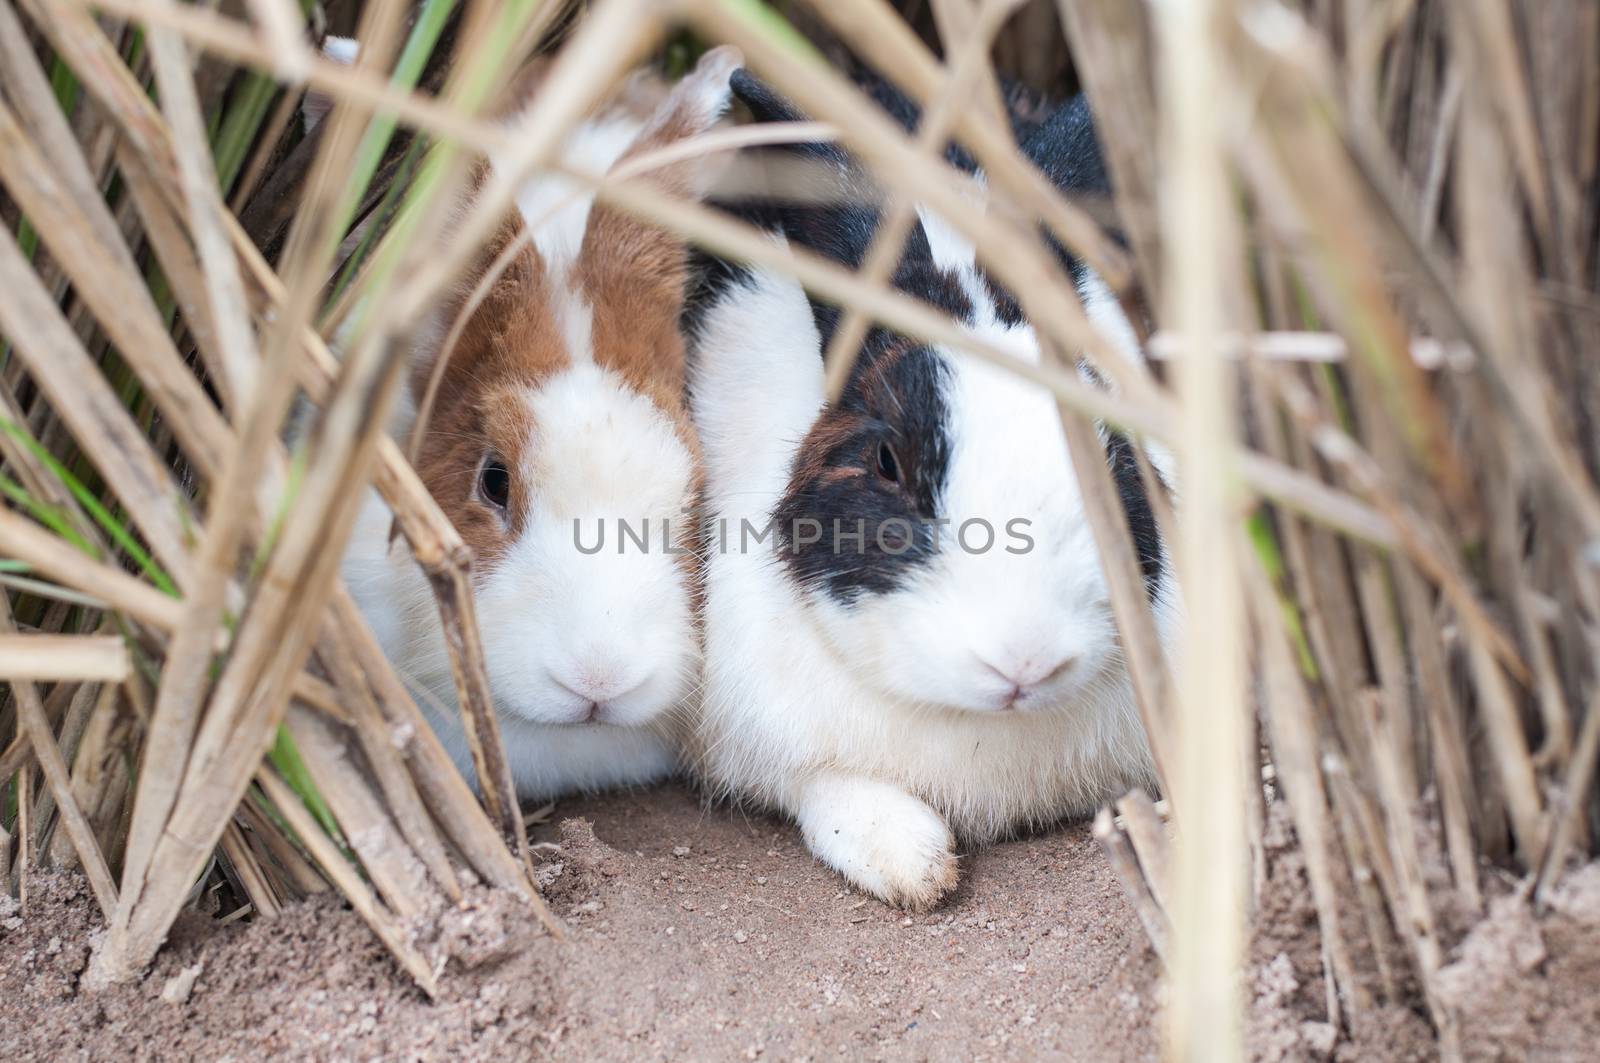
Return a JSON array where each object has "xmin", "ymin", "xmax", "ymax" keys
[{"xmin": 1061, "ymin": 0, "xmax": 1600, "ymax": 1057}]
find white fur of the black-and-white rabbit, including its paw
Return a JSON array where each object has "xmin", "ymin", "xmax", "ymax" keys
[{"xmin": 693, "ymin": 224, "xmax": 1179, "ymax": 908}]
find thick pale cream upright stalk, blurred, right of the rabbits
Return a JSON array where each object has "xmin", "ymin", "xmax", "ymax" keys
[{"xmin": 1157, "ymin": 0, "xmax": 1254, "ymax": 1060}]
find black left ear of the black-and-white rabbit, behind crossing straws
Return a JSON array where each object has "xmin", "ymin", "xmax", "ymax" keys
[{"xmin": 733, "ymin": 70, "xmax": 933, "ymax": 349}]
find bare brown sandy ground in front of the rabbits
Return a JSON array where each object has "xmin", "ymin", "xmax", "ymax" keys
[{"xmin": 0, "ymin": 786, "xmax": 1600, "ymax": 1063}]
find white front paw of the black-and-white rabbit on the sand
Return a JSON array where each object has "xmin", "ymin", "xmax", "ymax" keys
[{"xmin": 795, "ymin": 775, "xmax": 960, "ymax": 911}]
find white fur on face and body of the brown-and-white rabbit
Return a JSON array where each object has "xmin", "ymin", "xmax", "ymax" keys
[{"xmin": 342, "ymin": 365, "xmax": 699, "ymax": 797}]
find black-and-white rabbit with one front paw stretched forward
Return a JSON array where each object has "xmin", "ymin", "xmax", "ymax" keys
[{"xmin": 686, "ymin": 72, "xmax": 1179, "ymax": 908}]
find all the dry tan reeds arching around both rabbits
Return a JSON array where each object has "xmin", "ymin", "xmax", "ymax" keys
[{"xmin": 0, "ymin": 0, "xmax": 1600, "ymax": 1058}]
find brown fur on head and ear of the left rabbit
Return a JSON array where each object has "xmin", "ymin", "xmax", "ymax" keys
[{"xmin": 411, "ymin": 50, "xmax": 739, "ymax": 573}]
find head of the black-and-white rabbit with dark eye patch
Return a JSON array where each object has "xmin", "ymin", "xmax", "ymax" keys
[{"xmin": 699, "ymin": 72, "xmax": 1166, "ymax": 712}]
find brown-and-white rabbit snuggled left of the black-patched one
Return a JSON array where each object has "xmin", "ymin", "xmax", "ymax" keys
[{"xmin": 342, "ymin": 48, "xmax": 739, "ymax": 797}]
